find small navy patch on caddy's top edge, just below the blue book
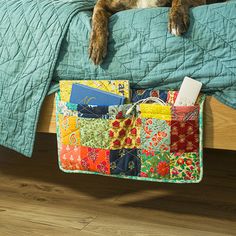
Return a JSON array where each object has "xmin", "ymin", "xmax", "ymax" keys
[{"xmin": 77, "ymin": 104, "xmax": 109, "ymax": 119}]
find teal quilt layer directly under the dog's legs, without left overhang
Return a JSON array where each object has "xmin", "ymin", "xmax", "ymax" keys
[{"xmin": 54, "ymin": 0, "xmax": 236, "ymax": 108}]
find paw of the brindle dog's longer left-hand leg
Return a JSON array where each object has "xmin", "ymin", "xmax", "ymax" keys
[{"xmin": 89, "ymin": 34, "xmax": 107, "ymax": 65}]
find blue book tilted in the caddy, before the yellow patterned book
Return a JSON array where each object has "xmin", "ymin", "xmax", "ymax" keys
[{"xmin": 70, "ymin": 84, "xmax": 125, "ymax": 106}]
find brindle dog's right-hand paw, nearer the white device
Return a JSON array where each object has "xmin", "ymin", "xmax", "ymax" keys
[{"xmin": 168, "ymin": 8, "xmax": 189, "ymax": 36}]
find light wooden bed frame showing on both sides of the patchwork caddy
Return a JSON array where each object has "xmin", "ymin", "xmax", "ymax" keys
[{"xmin": 38, "ymin": 95, "xmax": 236, "ymax": 150}]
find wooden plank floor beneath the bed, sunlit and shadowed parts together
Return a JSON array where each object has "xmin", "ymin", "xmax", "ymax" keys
[{"xmin": 0, "ymin": 134, "xmax": 236, "ymax": 236}]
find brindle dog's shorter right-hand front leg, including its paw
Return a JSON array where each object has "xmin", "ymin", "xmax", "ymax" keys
[{"xmin": 168, "ymin": 0, "xmax": 206, "ymax": 36}]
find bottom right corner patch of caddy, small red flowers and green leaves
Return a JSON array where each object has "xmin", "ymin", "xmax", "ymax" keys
[{"xmin": 170, "ymin": 153, "xmax": 200, "ymax": 180}]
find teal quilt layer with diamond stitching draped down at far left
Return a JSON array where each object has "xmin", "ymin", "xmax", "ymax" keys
[{"xmin": 0, "ymin": 0, "xmax": 94, "ymax": 156}]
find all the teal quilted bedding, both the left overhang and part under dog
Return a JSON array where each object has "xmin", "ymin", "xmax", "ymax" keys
[{"xmin": 0, "ymin": 0, "xmax": 236, "ymax": 159}]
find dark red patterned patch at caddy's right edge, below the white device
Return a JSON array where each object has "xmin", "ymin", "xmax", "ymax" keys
[{"xmin": 170, "ymin": 120, "xmax": 199, "ymax": 153}]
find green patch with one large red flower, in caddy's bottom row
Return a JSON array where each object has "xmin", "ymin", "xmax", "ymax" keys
[{"xmin": 140, "ymin": 150, "xmax": 170, "ymax": 179}]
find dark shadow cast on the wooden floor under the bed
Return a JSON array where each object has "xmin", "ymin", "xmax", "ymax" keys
[{"xmin": 0, "ymin": 134, "xmax": 236, "ymax": 220}]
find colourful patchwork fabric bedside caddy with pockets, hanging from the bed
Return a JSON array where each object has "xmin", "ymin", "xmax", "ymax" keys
[{"xmin": 56, "ymin": 87, "xmax": 205, "ymax": 183}]
